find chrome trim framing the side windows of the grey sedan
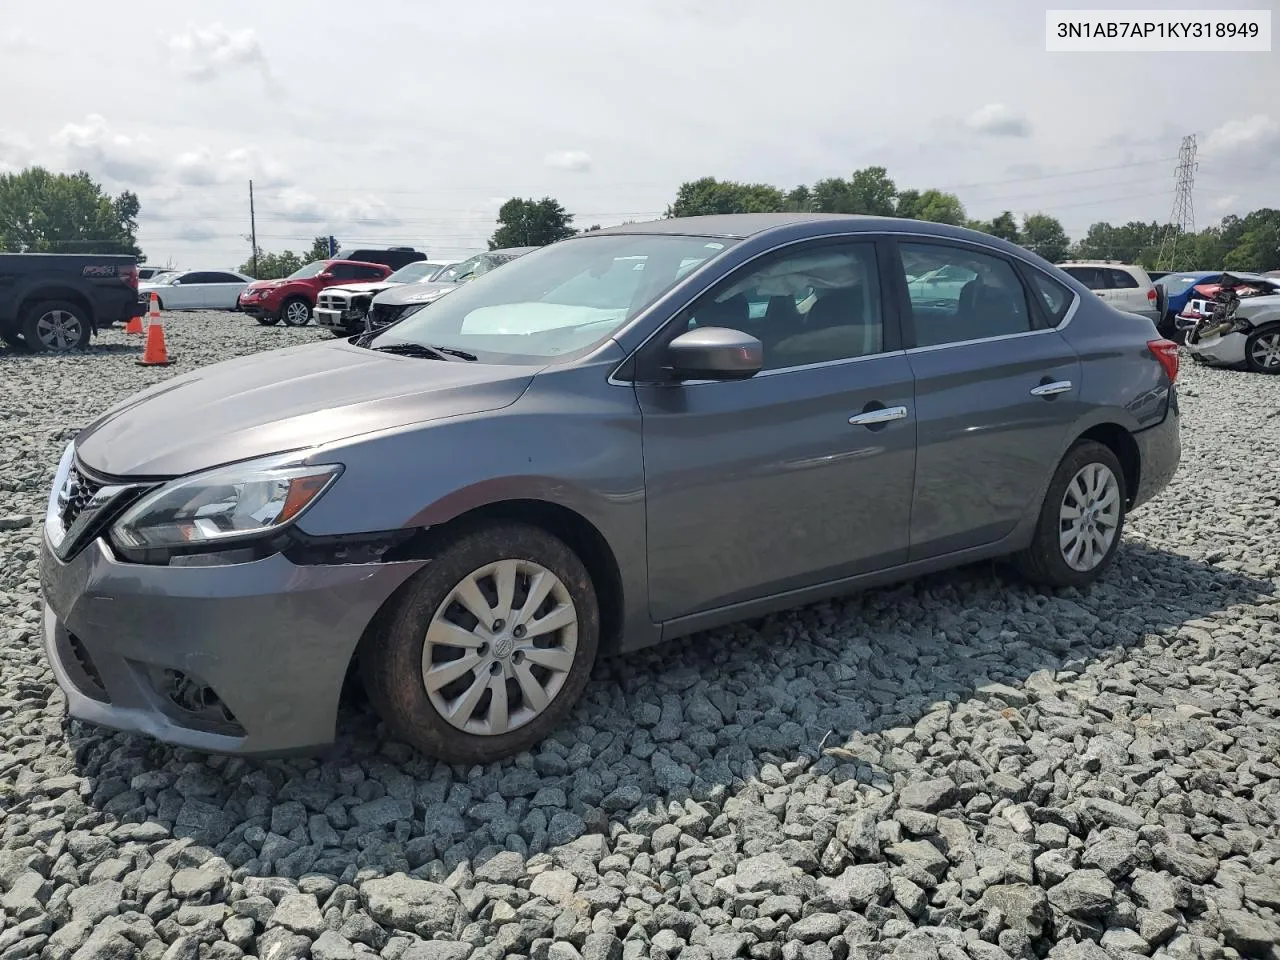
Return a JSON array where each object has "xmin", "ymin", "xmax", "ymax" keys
[{"xmin": 605, "ymin": 230, "xmax": 1083, "ymax": 388}]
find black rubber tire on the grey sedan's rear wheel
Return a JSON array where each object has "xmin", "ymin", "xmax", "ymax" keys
[{"xmin": 1014, "ymin": 440, "xmax": 1129, "ymax": 588}]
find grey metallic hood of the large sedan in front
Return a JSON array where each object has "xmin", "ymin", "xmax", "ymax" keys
[{"xmin": 76, "ymin": 340, "xmax": 535, "ymax": 477}]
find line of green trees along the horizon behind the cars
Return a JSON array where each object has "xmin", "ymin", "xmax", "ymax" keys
[{"xmin": 0, "ymin": 166, "xmax": 1280, "ymax": 279}]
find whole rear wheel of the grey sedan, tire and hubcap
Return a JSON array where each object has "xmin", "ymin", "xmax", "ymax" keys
[{"xmin": 1014, "ymin": 440, "xmax": 1128, "ymax": 588}]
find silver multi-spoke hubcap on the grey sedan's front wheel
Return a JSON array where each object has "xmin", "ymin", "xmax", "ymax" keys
[{"xmin": 422, "ymin": 559, "xmax": 577, "ymax": 736}]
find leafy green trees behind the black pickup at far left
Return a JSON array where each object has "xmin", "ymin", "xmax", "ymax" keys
[{"xmin": 0, "ymin": 166, "xmax": 145, "ymax": 262}]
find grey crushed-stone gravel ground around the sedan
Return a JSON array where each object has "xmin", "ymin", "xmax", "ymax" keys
[{"xmin": 0, "ymin": 314, "xmax": 1280, "ymax": 960}]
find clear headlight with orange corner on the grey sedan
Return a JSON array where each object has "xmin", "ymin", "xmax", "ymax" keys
[{"xmin": 111, "ymin": 457, "xmax": 342, "ymax": 553}]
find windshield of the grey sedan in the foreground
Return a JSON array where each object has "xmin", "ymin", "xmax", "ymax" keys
[{"xmin": 370, "ymin": 234, "xmax": 736, "ymax": 364}]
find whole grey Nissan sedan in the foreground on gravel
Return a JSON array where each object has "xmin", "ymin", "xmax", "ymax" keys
[{"xmin": 40, "ymin": 214, "xmax": 1181, "ymax": 764}]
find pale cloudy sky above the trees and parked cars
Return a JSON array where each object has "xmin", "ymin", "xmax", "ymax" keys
[{"xmin": 0, "ymin": 0, "xmax": 1280, "ymax": 268}]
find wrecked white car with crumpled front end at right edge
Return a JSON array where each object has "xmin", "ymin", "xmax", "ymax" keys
[{"xmin": 1178, "ymin": 274, "xmax": 1280, "ymax": 374}]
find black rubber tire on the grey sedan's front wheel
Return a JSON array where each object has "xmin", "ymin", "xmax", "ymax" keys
[{"xmin": 360, "ymin": 522, "xmax": 600, "ymax": 764}]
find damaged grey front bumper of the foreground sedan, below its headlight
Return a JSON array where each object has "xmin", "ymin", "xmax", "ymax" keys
[{"xmin": 41, "ymin": 534, "xmax": 422, "ymax": 755}]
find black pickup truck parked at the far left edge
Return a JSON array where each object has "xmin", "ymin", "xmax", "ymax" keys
[{"xmin": 0, "ymin": 253, "xmax": 146, "ymax": 352}]
